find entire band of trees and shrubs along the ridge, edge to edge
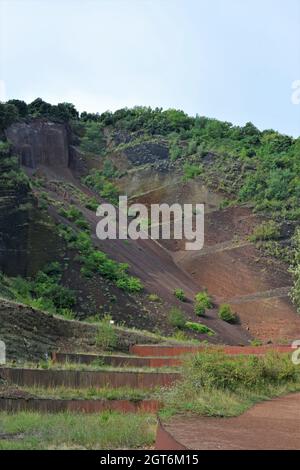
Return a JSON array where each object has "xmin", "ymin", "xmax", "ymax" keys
[{"xmin": 0, "ymin": 98, "xmax": 300, "ymax": 220}]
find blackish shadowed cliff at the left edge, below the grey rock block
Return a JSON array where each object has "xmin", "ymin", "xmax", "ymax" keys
[{"xmin": 0, "ymin": 141, "xmax": 62, "ymax": 276}]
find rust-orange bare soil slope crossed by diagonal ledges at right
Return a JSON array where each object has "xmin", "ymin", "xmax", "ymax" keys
[{"xmin": 173, "ymin": 207, "xmax": 300, "ymax": 342}]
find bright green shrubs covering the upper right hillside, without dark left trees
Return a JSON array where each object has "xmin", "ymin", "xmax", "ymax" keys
[{"xmin": 79, "ymin": 107, "xmax": 300, "ymax": 220}]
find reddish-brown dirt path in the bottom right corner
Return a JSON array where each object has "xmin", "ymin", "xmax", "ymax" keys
[{"xmin": 156, "ymin": 393, "xmax": 300, "ymax": 450}]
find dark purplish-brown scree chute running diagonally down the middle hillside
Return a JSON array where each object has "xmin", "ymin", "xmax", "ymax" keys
[{"xmin": 33, "ymin": 168, "xmax": 251, "ymax": 344}]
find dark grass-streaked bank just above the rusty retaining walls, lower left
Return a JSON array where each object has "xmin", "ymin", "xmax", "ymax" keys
[{"xmin": 0, "ymin": 299, "xmax": 162, "ymax": 360}]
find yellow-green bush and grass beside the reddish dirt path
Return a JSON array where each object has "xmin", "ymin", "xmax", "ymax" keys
[{"xmin": 162, "ymin": 348, "xmax": 300, "ymax": 416}]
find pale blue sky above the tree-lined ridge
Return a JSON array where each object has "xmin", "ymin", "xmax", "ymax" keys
[{"xmin": 0, "ymin": 0, "xmax": 300, "ymax": 137}]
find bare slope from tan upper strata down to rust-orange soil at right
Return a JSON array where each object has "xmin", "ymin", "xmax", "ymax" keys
[{"xmin": 124, "ymin": 169, "xmax": 300, "ymax": 343}]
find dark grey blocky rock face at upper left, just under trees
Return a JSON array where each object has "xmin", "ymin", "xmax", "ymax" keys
[{"xmin": 6, "ymin": 119, "xmax": 69, "ymax": 168}]
